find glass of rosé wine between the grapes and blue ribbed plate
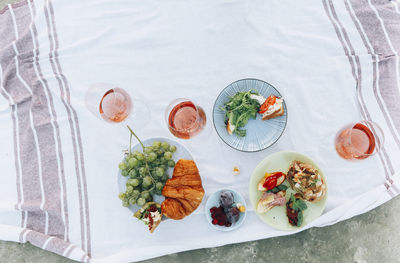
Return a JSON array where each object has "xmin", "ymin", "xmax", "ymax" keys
[{"xmin": 165, "ymin": 98, "xmax": 207, "ymax": 139}]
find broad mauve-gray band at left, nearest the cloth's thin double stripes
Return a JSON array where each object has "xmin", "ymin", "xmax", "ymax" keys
[{"xmin": 11, "ymin": 0, "xmax": 65, "ymax": 238}]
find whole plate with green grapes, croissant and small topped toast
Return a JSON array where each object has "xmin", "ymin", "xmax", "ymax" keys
[{"xmin": 118, "ymin": 127, "xmax": 204, "ymax": 232}]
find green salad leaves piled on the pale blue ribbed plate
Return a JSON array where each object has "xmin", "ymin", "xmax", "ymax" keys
[{"xmin": 222, "ymin": 90, "xmax": 260, "ymax": 137}]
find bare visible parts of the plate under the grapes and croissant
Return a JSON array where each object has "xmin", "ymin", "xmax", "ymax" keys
[{"xmin": 118, "ymin": 137, "xmax": 194, "ymax": 212}]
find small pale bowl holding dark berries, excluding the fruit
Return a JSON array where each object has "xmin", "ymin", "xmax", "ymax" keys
[{"xmin": 205, "ymin": 188, "xmax": 247, "ymax": 232}]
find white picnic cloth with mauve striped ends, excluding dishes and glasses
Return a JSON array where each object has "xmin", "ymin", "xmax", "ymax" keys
[{"xmin": 0, "ymin": 0, "xmax": 400, "ymax": 262}]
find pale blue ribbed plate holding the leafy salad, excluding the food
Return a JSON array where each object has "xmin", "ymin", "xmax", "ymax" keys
[{"xmin": 213, "ymin": 79, "xmax": 287, "ymax": 152}]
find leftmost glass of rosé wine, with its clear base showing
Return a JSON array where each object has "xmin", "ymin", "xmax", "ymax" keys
[{"xmin": 85, "ymin": 83, "xmax": 148, "ymax": 125}]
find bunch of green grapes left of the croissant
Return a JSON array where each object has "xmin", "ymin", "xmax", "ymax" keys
[{"xmin": 119, "ymin": 141, "xmax": 176, "ymax": 207}]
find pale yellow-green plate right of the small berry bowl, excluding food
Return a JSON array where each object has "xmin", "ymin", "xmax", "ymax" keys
[{"xmin": 249, "ymin": 151, "xmax": 328, "ymax": 231}]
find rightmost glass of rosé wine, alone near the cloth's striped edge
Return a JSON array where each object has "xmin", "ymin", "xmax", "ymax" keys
[{"xmin": 335, "ymin": 121, "xmax": 385, "ymax": 161}]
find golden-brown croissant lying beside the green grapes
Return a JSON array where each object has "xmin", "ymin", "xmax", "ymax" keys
[{"xmin": 161, "ymin": 159, "xmax": 204, "ymax": 220}]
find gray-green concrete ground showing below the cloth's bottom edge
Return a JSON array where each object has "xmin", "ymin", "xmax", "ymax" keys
[{"xmin": 0, "ymin": 197, "xmax": 400, "ymax": 263}]
